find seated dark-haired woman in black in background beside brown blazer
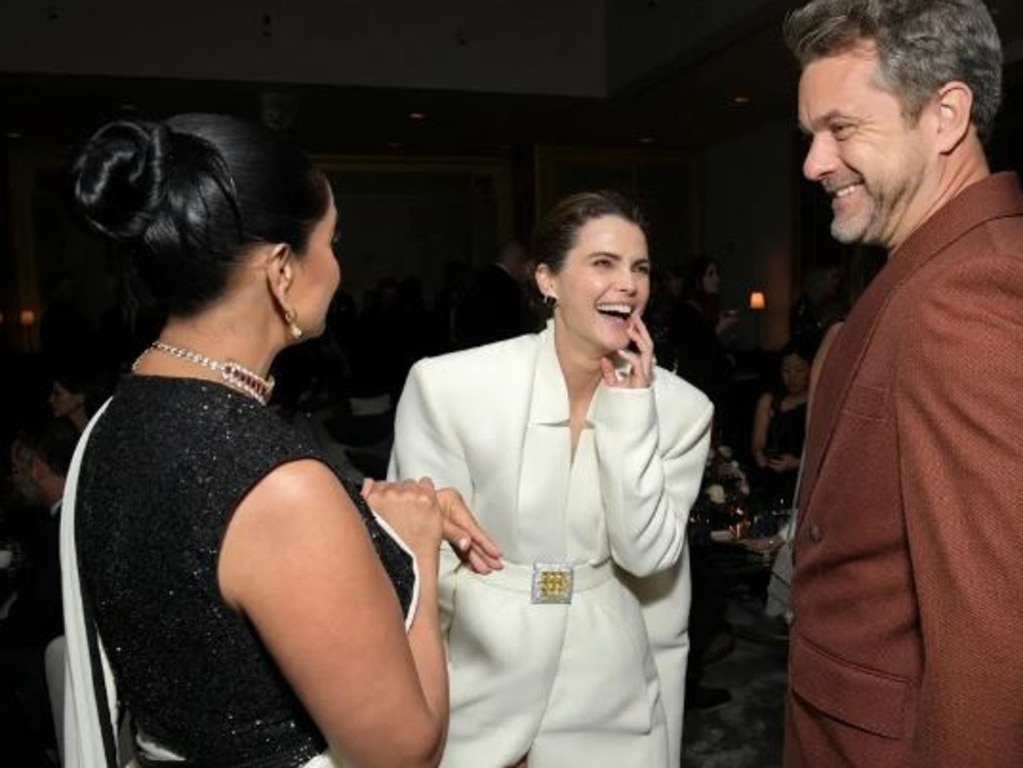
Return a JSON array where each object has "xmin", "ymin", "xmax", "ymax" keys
[{"xmin": 750, "ymin": 341, "xmax": 813, "ymax": 507}]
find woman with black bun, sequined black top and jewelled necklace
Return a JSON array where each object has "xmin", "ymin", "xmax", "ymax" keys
[{"xmin": 62, "ymin": 115, "xmax": 498, "ymax": 768}]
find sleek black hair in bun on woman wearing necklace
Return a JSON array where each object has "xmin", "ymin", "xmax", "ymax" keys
[{"xmin": 71, "ymin": 115, "xmax": 329, "ymax": 316}]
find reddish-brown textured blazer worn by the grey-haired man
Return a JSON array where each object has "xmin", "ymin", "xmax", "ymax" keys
[{"xmin": 785, "ymin": 174, "xmax": 1023, "ymax": 768}]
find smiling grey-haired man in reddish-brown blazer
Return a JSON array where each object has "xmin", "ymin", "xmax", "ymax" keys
[{"xmin": 785, "ymin": 0, "xmax": 1023, "ymax": 768}]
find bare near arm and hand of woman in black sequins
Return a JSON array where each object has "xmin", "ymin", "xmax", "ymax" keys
[{"xmin": 219, "ymin": 460, "xmax": 447, "ymax": 768}]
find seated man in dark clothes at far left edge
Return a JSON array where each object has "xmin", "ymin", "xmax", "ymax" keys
[{"xmin": 0, "ymin": 418, "xmax": 79, "ymax": 766}]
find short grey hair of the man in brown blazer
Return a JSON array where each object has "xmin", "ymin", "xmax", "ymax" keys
[{"xmin": 784, "ymin": 0, "xmax": 1002, "ymax": 140}]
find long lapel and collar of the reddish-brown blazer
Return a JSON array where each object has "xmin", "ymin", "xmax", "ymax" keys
[{"xmin": 797, "ymin": 173, "xmax": 1023, "ymax": 527}]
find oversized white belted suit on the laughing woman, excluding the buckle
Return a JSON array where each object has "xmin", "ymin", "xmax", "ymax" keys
[{"xmin": 389, "ymin": 325, "xmax": 712, "ymax": 768}]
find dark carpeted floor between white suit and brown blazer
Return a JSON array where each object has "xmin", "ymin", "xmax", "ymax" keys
[{"xmin": 682, "ymin": 592, "xmax": 788, "ymax": 768}]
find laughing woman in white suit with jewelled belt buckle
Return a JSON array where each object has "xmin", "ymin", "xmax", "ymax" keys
[{"xmin": 391, "ymin": 192, "xmax": 712, "ymax": 768}]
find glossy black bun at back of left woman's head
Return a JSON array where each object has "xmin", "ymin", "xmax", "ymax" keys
[{"xmin": 71, "ymin": 122, "xmax": 170, "ymax": 240}]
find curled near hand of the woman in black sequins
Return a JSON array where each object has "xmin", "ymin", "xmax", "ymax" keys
[{"xmin": 362, "ymin": 478, "xmax": 444, "ymax": 554}]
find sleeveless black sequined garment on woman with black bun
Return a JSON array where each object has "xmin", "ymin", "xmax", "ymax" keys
[{"xmin": 76, "ymin": 376, "xmax": 415, "ymax": 768}]
